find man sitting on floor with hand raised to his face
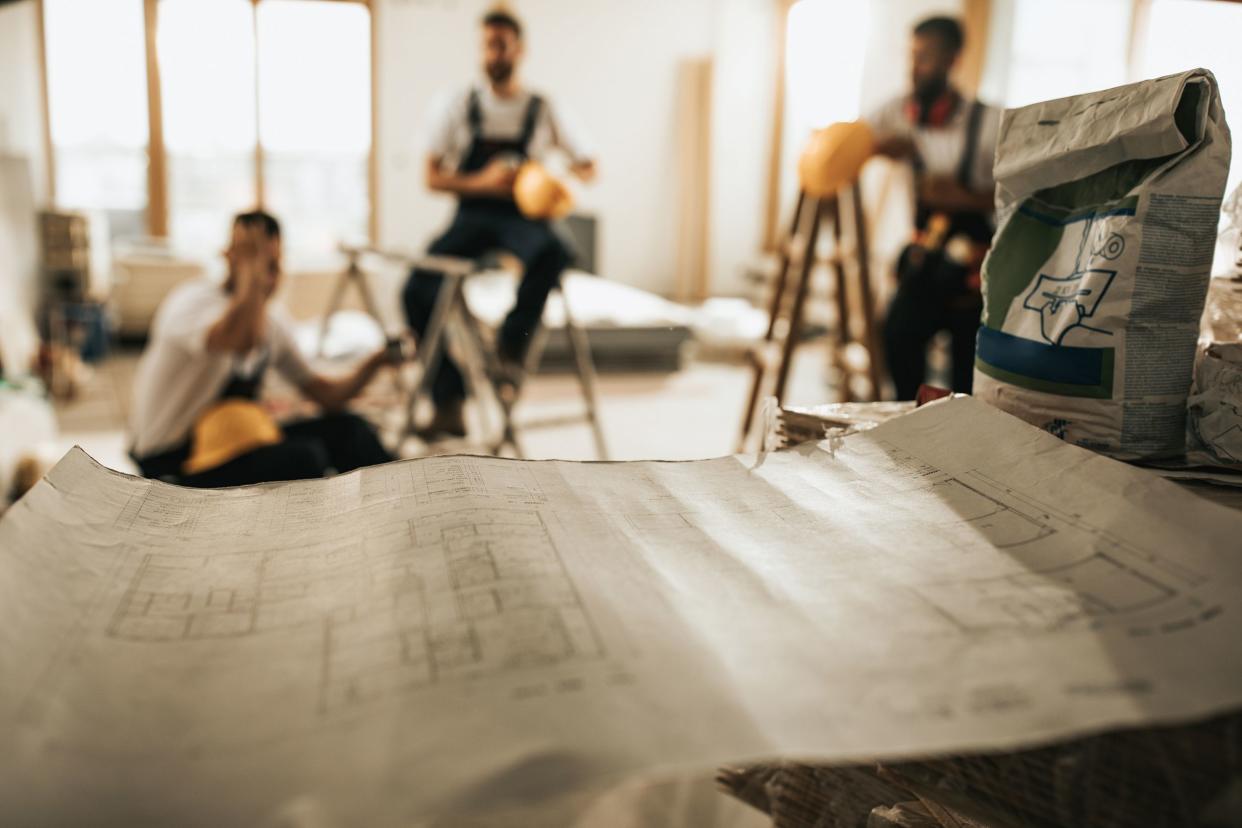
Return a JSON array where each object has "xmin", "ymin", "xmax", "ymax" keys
[{"xmin": 130, "ymin": 211, "xmax": 392, "ymax": 488}]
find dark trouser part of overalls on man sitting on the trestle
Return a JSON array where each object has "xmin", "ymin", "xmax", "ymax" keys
[{"xmin": 402, "ymin": 207, "xmax": 573, "ymax": 405}]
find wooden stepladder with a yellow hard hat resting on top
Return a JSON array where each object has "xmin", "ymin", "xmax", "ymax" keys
[{"xmin": 739, "ymin": 180, "xmax": 883, "ymax": 451}]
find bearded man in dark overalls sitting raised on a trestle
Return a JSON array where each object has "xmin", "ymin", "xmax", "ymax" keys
[{"xmin": 402, "ymin": 11, "xmax": 595, "ymax": 439}]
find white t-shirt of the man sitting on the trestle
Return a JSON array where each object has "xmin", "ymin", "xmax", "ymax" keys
[{"xmin": 427, "ymin": 86, "xmax": 591, "ymax": 170}]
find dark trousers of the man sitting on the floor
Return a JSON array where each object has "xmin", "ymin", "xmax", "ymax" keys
[{"xmin": 134, "ymin": 413, "xmax": 392, "ymax": 489}]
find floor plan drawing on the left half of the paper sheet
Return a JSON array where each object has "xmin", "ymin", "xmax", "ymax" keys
[{"xmin": 106, "ymin": 508, "xmax": 605, "ymax": 714}]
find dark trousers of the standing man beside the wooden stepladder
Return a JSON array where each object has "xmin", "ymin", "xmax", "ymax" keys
[{"xmin": 884, "ymin": 252, "xmax": 982, "ymax": 400}]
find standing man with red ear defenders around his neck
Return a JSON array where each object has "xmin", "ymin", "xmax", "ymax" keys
[{"xmin": 866, "ymin": 17, "xmax": 1000, "ymax": 400}]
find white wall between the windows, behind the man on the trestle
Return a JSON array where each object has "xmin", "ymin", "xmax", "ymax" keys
[{"xmin": 376, "ymin": 0, "xmax": 775, "ymax": 294}]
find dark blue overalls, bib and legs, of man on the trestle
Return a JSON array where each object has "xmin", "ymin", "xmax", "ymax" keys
[{"xmin": 402, "ymin": 91, "xmax": 571, "ymax": 406}]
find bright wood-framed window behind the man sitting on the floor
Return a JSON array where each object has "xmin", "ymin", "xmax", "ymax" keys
[{"xmin": 45, "ymin": 0, "xmax": 371, "ymax": 267}]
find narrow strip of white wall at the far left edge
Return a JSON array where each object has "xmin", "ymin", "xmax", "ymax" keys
[{"xmin": 0, "ymin": 0, "xmax": 48, "ymax": 205}]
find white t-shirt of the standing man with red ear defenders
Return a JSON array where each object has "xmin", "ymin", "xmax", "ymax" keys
[{"xmin": 864, "ymin": 97, "xmax": 1001, "ymax": 192}]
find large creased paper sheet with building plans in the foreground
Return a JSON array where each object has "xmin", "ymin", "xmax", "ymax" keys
[{"xmin": 0, "ymin": 398, "xmax": 1242, "ymax": 826}]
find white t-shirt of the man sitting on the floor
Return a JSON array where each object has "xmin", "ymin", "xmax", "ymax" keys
[{"xmin": 129, "ymin": 279, "xmax": 314, "ymax": 457}]
